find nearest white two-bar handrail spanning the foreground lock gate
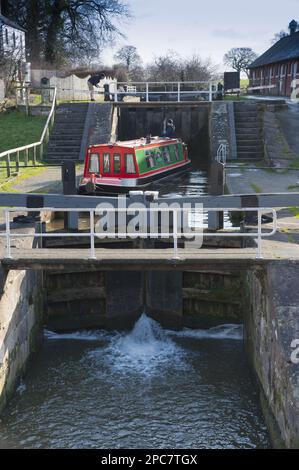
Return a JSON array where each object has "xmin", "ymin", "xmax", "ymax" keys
[{"xmin": 0, "ymin": 207, "xmax": 277, "ymax": 259}]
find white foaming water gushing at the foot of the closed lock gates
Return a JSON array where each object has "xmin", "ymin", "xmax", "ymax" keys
[{"xmin": 45, "ymin": 314, "xmax": 243, "ymax": 376}]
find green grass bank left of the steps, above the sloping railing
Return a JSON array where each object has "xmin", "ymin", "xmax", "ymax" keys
[{"xmin": 0, "ymin": 111, "xmax": 46, "ymax": 153}]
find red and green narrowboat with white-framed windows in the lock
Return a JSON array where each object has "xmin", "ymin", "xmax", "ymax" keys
[{"xmin": 78, "ymin": 137, "xmax": 191, "ymax": 195}]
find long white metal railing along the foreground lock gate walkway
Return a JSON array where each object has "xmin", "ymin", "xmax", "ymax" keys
[{"xmin": 0, "ymin": 207, "xmax": 277, "ymax": 259}]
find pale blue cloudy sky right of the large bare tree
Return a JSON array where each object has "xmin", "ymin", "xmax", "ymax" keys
[{"xmin": 102, "ymin": 0, "xmax": 299, "ymax": 71}]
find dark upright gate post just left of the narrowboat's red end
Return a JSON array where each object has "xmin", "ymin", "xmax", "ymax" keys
[{"xmin": 61, "ymin": 162, "xmax": 79, "ymax": 231}]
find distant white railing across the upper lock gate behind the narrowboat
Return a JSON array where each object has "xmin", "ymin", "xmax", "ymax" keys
[{"xmin": 113, "ymin": 81, "xmax": 218, "ymax": 103}]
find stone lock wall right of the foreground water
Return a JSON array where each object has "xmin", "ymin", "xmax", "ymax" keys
[{"xmin": 245, "ymin": 261, "xmax": 299, "ymax": 448}]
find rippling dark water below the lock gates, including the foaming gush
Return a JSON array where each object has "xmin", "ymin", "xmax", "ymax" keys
[{"xmin": 0, "ymin": 315, "xmax": 270, "ymax": 449}]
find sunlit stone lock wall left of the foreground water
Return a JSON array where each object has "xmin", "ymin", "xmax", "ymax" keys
[{"xmin": 0, "ymin": 271, "xmax": 43, "ymax": 412}]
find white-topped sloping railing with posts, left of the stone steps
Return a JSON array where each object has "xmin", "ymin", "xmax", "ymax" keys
[{"xmin": 0, "ymin": 88, "xmax": 57, "ymax": 178}]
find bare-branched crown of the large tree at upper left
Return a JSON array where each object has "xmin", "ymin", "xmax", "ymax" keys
[{"xmin": 3, "ymin": 0, "xmax": 130, "ymax": 65}]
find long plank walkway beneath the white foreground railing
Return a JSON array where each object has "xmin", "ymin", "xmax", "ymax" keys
[{"xmin": 2, "ymin": 244, "xmax": 299, "ymax": 271}]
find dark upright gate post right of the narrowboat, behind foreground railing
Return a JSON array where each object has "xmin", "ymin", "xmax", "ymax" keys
[{"xmin": 208, "ymin": 161, "xmax": 225, "ymax": 230}]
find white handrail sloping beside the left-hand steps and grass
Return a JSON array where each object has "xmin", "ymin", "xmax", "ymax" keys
[{"xmin": 0, "ymin": 87, "xmax": 57, "ymax": 177}]
